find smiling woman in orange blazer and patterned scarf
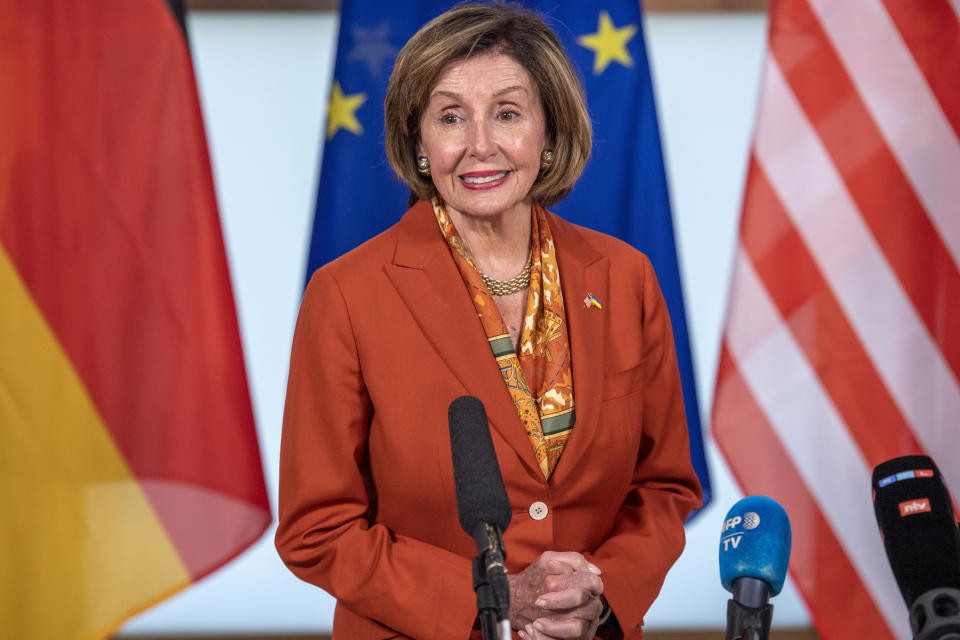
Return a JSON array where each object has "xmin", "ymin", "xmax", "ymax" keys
[{"xmin": 276, "ymin": 4, "xmax": 700, "ymax": 640}]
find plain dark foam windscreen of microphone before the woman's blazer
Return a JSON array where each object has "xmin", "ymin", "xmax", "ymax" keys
[{"xmin": 448, "ymin": 396, "xmax": 510, "ymax": 536}]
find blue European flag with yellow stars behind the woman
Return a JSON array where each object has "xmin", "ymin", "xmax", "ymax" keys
[{"xmin": 307, "ymin": 0, "xmax": 711, "ymax": 505}]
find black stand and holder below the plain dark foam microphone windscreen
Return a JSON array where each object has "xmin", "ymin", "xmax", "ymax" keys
[{"xmin": 473, "ymin": 523, "xmax": 510, "ymax": 640}]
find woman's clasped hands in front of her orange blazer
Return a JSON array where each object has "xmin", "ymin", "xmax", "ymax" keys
[{"xmin": 508, "ymin": 551, "xmax": 603, "ymax": 640}]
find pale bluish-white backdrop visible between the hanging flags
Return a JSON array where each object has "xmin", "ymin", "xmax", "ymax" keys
[{"xmin": 118, "ymin": 13, "xmax": 809, "ymax": 634}]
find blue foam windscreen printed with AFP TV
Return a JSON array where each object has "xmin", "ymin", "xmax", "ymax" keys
[{"xmin": 720, "ymin": 496, "xmax": 791, "ymax": 596}]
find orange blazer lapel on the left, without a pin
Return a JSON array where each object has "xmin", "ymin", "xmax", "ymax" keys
[{"xmin": 385, "ymin": 202, "xmax": 544, "ymax": 479}]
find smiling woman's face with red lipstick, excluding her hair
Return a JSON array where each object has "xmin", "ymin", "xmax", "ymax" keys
[{"xmin": 417, "ymin": 53, "xmax": 547, "ymax": 226}]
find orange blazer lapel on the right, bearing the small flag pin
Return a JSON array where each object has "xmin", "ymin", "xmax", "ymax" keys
[{"xmin": 550, "ymin": 214, "xmax": 614, "ymax": 483}]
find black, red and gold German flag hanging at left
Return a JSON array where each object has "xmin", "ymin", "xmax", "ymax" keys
[{"xmin": 0, "ymin": 0, "xmax": 270, "ymax": 640}]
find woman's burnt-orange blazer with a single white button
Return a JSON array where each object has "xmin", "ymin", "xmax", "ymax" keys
[{"xmin": 276, "ymin": 202, "xmax": 701, "ymax": 640}]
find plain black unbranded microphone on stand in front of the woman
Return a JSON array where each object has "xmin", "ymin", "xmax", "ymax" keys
[{"xmin": 448, "ymin": 396, "xmax": 511, "ymax": 640}]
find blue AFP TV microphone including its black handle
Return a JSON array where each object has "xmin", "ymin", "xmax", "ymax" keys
[{"xmin": 720, "ymin": 496, "xmax": 790, "ymax": 640}]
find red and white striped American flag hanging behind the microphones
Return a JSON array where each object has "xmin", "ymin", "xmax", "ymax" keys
[{"xmin": 713, "ymin": 0, "xmax": 960, "ymax": 640}]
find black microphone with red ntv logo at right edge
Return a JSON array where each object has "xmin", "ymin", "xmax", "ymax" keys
[{"xmin": 871, "ymin": 456, "xmax": 960, "ymax": 640}]
